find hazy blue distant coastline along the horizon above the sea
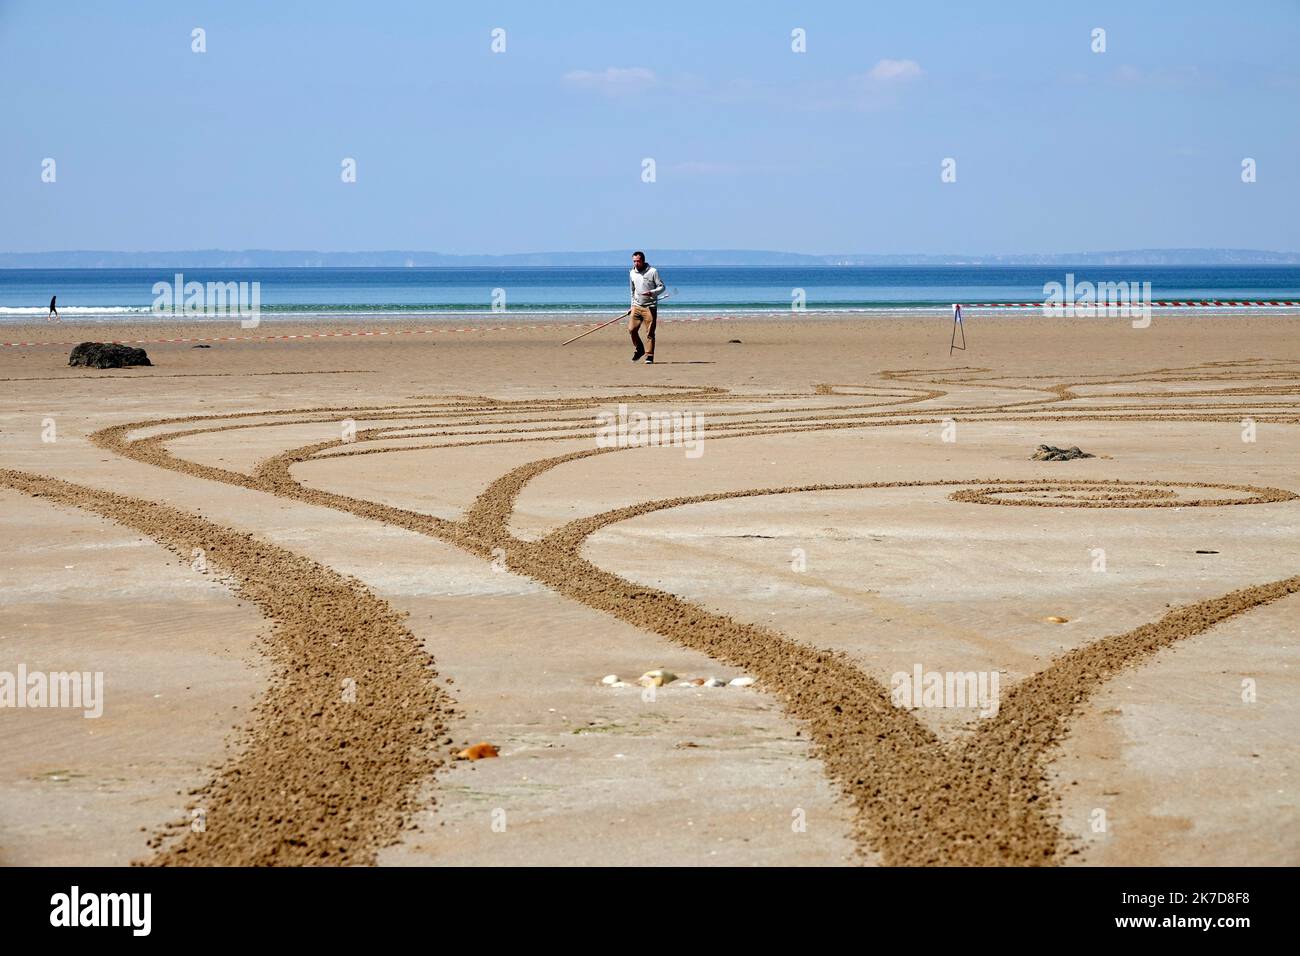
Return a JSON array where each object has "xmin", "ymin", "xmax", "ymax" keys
[{"xmin": 0, "ymin": 248, "xmax": 1300, "ymax": 269}]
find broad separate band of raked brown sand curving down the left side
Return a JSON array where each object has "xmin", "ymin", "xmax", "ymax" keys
[{"xmin": 0, "ymin": 470, "xmax": 454, "ymax": 866}]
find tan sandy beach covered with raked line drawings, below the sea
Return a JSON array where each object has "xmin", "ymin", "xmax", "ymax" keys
[{"xmin": 0, "ymin": 313, "xmax": 1300, "ymax": 866}]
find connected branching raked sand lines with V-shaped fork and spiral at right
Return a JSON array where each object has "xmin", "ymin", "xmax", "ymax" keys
[{"xmin": 8, "ymin": 363, "xmax": 1300, "ymax": 865}]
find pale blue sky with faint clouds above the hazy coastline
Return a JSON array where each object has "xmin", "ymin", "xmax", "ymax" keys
[{"xmin": 0, "ymin": 0, "xmax": 1300, "ymax": 254}]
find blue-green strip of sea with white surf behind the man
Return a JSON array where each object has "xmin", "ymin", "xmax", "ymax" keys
[{"xmin": 0, "ymin": 265, "xmax": 1300, "ymax": 324}]
